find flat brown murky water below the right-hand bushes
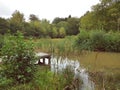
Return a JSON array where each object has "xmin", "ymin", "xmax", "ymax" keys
[{"xmin": 79, "ymin": 52, "xmax": 120, "ymax": 71}]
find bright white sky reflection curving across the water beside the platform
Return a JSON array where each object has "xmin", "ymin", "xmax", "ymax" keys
[{"xmin": 51, "ymin": 57, "xmax": 94, "ymax": 90}]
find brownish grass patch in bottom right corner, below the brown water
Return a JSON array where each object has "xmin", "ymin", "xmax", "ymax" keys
[{"xmin": 89, "ymin": 71, "xmax": 120, "ymax": 90}]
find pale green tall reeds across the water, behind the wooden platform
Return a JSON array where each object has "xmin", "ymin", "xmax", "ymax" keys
[{"xmin": 34, "ymin": 36, "xmax": 80, "ymax": 56}]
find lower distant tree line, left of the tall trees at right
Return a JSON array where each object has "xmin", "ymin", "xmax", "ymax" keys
[{"xmin": 0, "ymin": 11, "xmax": 79, "ymax": 38}]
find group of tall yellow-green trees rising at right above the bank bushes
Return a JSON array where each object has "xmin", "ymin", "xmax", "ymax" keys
[{"xmin": 80, "ymin": 0, "xmax": 120, "ymax": 31}]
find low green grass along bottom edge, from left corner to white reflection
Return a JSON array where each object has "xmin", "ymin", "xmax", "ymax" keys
[{"xmin": 0, "ymin": 66, "xmax": 78, "ymax": 90}]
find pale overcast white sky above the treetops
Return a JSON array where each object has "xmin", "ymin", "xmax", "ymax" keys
[{"xmin": 0, "ymin": 0, "xmax": 99, "ymax": 21}]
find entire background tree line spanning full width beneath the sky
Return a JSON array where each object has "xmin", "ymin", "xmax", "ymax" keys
[{"xmin": 0, "ymin": 0, "xmax": 120, "ymax": 38}]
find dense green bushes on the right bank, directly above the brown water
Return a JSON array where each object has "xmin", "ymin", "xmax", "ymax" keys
[{"xmin": 76, "ymin": 31, "xmax": 120, "ymax": 52}]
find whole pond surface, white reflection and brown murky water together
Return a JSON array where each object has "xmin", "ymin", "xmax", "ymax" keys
[{"xmin": 38, "ymin": 52, "xmax": 120, "ymax": 90}]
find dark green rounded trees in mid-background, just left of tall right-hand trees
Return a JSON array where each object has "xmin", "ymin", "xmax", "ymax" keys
[{"xmin": 52, "ymin": 16, "xmax": 79, "ymax": 35}]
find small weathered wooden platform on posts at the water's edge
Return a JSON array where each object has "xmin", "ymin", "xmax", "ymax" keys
[{"xmin": 36, "ymin": 52, "xmax": 51, "ymax": 65}]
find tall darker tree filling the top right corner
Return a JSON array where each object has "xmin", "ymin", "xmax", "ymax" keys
[{"xmin": 93, "ymin": 0, "xmax": 120, "ymax": 30}]
